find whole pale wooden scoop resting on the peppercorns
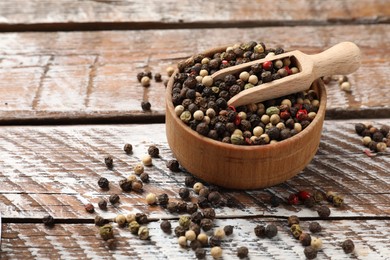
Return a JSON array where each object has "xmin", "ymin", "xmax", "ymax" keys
[{"xmin": 211, "ymin": 42, "xmax": 360, "ymax": 107}]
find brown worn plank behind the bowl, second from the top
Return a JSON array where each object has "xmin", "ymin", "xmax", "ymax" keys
[{"xmin": 0, "ymin": 25, "xmax": 390, "ymax": 124}]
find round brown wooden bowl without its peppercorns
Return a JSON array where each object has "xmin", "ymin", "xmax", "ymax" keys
[{"xmin": 166, "ymin": 47, "xmax": 326, "ymax": 189}]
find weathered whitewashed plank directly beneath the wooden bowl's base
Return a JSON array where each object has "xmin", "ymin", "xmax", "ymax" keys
[{"xmin": 0, "ymin": 119, "xmax": 390, "ymax": 221}]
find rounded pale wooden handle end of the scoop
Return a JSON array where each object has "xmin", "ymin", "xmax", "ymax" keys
[{"xmin": 309, "ymin": 42, "xmax": 361, "ymax": 78}]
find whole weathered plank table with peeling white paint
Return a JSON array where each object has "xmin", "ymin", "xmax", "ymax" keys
[{"xmin": 0, "ymin": 0, "xmax": 390, "ymax": 259}]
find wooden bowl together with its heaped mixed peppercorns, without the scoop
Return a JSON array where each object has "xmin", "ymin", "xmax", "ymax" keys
[{"xmin": 166, "ymin": 42, "xmax": 326, "ymax": 189}]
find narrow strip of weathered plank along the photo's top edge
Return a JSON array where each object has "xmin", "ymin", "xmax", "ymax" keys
[{"xmin": 0, "ymin": 0, "xmax": 390, "ymax": 31}]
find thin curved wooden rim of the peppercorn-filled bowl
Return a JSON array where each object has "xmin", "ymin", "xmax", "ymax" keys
[{"xmin": 165, "ymin": 47, "xmax": 327, "ymax": 152}]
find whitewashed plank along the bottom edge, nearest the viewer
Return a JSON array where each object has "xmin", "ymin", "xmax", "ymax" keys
[{"xmin": 0, "ymin": 218, "xmax": 390, "ymax": 259}]
